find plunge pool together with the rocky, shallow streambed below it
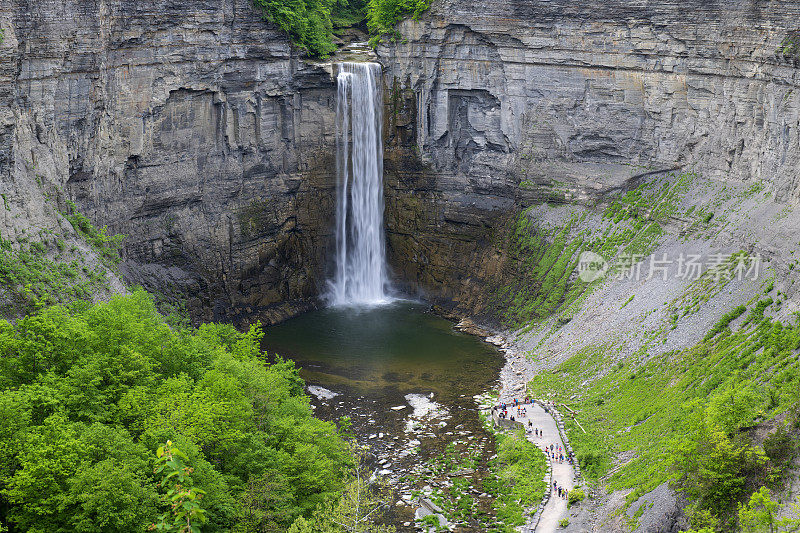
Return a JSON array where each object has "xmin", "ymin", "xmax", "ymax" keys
[{"xmin": 264, "ymin": 302, "xmax": 504, "ymax": 532}]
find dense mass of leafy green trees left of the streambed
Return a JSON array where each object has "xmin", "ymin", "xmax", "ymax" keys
[{"xmin": 0, "ymin": 291, "xmax": 351, "ymax": 532}]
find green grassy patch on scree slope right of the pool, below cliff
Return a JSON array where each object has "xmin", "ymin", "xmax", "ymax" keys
[{"xmin": 497, "ymin": 174, "xmax": 696, "ymax": 328}]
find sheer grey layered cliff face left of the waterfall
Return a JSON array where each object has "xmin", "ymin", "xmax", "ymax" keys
[{"xmin": 0, "ymin": 0, "xmax": 335, "ymax": 318}]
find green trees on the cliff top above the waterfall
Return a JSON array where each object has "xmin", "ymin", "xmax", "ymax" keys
[{"xmin": 253, "ymin": 0, "xmax": 430, "ymax": 56}]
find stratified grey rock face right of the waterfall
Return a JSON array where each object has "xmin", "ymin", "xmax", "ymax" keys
[{"xmin": 379, "ymin": 0, "xmax": 800, "ymax": 312}]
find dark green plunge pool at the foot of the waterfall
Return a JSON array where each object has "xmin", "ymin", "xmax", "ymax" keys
[{"xmin": 264, "ymin": 301, "xmax": 503, "ymax": 403}]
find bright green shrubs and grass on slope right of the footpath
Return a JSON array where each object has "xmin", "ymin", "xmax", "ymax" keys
[{"xmin": 529, "ymin": 302, "xmax": 800, "ymax": 529}]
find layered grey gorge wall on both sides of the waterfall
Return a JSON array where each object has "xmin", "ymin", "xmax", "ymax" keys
[{"xmin": 0, "ymin": 0, "xmax": 800, "ymax": 320}]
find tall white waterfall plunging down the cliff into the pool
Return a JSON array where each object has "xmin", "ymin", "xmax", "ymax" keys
[{"xmin": 327, "ymin": 63, "xmax": 390, "ymax": 306}]
